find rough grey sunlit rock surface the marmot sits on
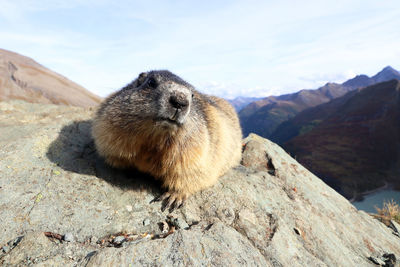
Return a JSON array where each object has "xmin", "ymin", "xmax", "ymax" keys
[{"xmin": 0, "ymin": 101, "xmax": 400, "ymax": 266}]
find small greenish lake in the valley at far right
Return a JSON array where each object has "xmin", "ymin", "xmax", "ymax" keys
[{"xmin": 352, "ymin": 189, "xmax": 400, "ymax": 213}]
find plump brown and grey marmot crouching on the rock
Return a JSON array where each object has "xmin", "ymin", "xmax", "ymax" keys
[{"xmin": 92, "ymin": 70, "xmax": 242, "ymax": 211}]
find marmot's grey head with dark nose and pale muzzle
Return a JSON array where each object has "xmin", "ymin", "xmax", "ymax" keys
[{"xmin": 122, "ymin": 70, "xmax": 194, "ymax": 127}]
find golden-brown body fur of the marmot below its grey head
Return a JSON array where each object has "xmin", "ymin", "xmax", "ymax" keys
[{"xmin": 92, "ymin": 70, "xmax": 242, "ymax": 205}]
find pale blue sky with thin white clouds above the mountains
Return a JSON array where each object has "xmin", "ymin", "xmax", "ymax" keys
[{"xmin": 0, "ymin": 0, "xmax": 400, "ymax": 98}]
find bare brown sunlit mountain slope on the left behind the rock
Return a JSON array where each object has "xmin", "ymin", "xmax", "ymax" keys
[{"xmin": 0, "ymin": 49, "xmax": 101, "ymax": 107}]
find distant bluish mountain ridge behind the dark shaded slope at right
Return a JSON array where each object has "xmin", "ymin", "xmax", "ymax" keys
[{"xmin": 239, "ymin": 66, "xmax": 400, "ymax": 138}]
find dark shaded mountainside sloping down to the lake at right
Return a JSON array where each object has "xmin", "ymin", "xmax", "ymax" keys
[{"xmin": 282, "ymin": 80, "xmax": 400, "ymax": 198}]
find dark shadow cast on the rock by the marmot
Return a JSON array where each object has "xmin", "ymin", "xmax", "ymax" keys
[{"xmin": 46, "ymin": 120, "xmax": 161, "ymax": 195}]
